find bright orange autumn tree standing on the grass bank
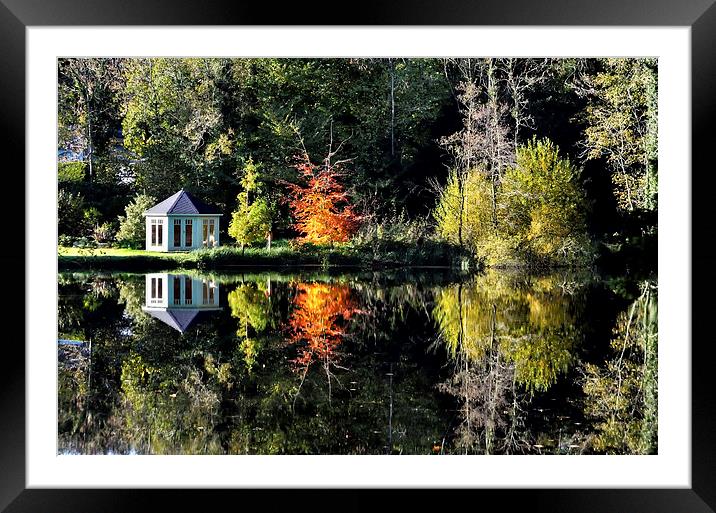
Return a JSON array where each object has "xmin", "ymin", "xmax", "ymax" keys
[{"xmin": 286, "ymin": 153, "xmax": 360, "ymax": 244}]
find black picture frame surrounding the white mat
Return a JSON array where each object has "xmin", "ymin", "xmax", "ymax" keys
[{"xmin": 0, "ymin": 0, "xmax": 716, "ymax": 513}]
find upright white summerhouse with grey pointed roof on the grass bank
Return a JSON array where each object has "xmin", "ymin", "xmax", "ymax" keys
[{"xmin": 144, "ymin": 189, "xmax": 221, "ymax": 252}]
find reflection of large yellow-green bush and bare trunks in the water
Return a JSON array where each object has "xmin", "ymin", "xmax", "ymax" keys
[{"xmin": 433, "ymin": 271, "xmax": 579, "ymax": 454}]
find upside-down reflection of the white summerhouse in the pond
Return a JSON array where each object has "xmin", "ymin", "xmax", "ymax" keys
[{"xmin": 142, "ymin": 273, "xmax": 221, "ymax": 333}]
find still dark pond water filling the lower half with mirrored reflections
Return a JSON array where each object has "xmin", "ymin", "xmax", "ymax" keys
[{"xmin": 58, "ymin": 271, "xmax": 657, "ymax": 455}]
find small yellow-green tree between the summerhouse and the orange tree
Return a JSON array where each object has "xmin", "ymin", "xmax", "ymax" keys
[{"xmin": 229, "ymin": 159, "xmax": 273, "ymax": 252}]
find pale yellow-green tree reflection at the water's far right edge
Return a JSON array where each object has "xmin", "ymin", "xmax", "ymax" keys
[{"xmin": 583, "ymin": 281, "xmax": 657, "ymax": 454}]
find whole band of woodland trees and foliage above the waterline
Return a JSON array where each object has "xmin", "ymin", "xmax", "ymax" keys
[{"xmin": 57, "ymin": 57, "xmax": 658, "ymax": 276}]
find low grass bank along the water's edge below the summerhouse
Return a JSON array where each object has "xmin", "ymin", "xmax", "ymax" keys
[{"xmin": 58, "ymin": 241, "xmax": 478, "ymax": 271}]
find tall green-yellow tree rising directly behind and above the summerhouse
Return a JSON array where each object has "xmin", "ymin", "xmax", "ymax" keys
[{"xmin": 122, "ymin": 58, "xmax": 236, "ymax": 207}]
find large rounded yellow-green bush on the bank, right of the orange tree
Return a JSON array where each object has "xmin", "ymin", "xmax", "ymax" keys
[{"xmin": 433, "ymin": 139, "xmax": 593, "ymax": 266}]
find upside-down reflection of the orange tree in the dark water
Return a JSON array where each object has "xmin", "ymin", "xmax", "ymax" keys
[{"xmin": 289, "ymin": 283, "xmax": 358, "ymax": 393}]
